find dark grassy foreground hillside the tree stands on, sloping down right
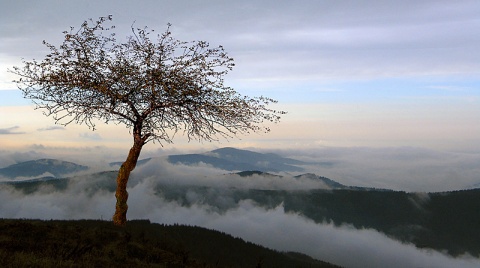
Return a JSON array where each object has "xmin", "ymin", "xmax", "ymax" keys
[{"xmin": 0, "ymin": 219, "xmax": 337, "ymax": 267}]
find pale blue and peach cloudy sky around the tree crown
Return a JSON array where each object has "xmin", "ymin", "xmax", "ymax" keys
[{"xmin": 0, "ymin": 0, "xmax": 480, "ymax": 153}]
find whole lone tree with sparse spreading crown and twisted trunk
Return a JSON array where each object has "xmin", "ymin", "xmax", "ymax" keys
[{"xmin": 10, "ymin": 16, "xmax": 285, "ymax": 226}]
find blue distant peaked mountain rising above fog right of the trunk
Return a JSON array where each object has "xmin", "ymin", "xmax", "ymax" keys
[{"xmin": 168, "ymin": 147, "xmax": 306, "ymax": 172}]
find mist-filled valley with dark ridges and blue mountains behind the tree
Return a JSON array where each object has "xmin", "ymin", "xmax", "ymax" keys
[{"xmin": 0, "ymin": 148, "xmax": 480, "ymax": 267}]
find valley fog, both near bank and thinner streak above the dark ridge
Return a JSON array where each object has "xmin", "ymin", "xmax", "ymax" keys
[{"xmin": 0, "ymin": 154, "xmax": 480, "ymax": 267}]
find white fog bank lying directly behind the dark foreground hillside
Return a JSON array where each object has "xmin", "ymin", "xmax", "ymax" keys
[{"xmin": 0, "ymin": 168, "xmax": 480, "ymax": 267}]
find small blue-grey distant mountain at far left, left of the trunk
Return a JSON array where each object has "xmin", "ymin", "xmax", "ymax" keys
[{"xmin": 0, "ymin": 159, "xmax": 88, "ymax": 178}]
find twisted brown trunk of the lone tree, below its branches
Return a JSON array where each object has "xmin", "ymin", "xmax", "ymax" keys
[{"xmin": 113, "ymin": 139, "xmax": 143, "ymax": 226}]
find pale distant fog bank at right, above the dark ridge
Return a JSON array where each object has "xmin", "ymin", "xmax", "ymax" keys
[{"xmin": 266, "ymin": 147, "xmax": 480, "ymax": 192}]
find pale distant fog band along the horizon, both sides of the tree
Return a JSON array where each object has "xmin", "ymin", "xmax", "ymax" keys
[{"xmin": 0, "ymin": 145, "xmax": 480, "ymax": 192}]
